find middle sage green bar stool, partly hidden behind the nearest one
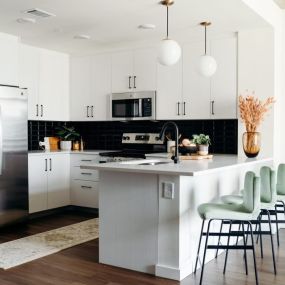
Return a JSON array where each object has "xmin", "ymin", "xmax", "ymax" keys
[{"xmin": 220, "ymin": 166, "xmax": 279, "ymax": 274}]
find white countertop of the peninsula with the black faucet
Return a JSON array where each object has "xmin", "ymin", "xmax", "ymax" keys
[{"xmin": 80, "ymin": 155, "xmax": 273, "ymax": 176}]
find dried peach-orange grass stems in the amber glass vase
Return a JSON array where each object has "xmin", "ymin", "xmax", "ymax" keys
[{"xmin": 239, "ymin": 92, "xmax": 275, "ymax": 132}]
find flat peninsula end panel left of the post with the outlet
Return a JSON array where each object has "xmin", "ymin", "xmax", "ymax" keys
[{"xmin": 99, "ymin": 171, "xmax": 158, "ymax": 274}]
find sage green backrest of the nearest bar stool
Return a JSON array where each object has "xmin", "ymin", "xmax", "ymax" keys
[{"xmin": 243, "ymin": 171, "xmax": 260, "ymax": 213}]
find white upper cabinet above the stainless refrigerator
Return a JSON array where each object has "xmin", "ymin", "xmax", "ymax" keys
[{"xmin": 0, "ymin": 33, "xmax": 19, "ymax": 86}]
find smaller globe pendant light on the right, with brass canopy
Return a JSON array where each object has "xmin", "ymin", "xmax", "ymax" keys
[{"xmin": 198, "ymin": 22, "xmax": 217, "ymax": 77}]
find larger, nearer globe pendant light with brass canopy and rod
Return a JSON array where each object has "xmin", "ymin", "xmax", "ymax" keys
[{"xmin": 157, "ymin": 0, "xmax": 181, "ymax": 66}]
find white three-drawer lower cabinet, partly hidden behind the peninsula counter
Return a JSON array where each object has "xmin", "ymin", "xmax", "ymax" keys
[{"xmin": 70, "ymin": 154, "xmax": 99, "ymax": 208}]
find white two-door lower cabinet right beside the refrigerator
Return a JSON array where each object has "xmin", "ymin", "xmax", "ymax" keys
[{"xmin": 29, "ymin": 154, "xmax": 70, "ymax": 213}]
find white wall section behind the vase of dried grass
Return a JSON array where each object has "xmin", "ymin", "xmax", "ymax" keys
[{"xmin": 238, "ymin": 28, "xmax": 275, "ymax": 157}]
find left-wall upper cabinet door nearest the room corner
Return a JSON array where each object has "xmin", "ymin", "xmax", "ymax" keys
[{"xmin": 39, "ymin": 49, "xmax": 69, "ymax": 121}]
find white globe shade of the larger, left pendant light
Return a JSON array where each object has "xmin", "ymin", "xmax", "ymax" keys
[{"xmin": 157, "ymin": 39, "xmax": 181, "ymax": 66}]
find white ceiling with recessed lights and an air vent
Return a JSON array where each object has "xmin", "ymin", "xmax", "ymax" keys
[{"xmin": 0, "ymin": 0, "xmax": 270, "ymax": 54}]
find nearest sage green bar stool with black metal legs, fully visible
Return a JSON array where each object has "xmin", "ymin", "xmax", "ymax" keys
[{"xmin": 194, "ymin": 171, "xmax": 260, "ymax": 285}]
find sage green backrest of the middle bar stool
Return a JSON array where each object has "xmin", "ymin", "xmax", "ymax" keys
[{"xmin": 260, "ymin": 166, "xmax": 277, "ymax": 203}]
